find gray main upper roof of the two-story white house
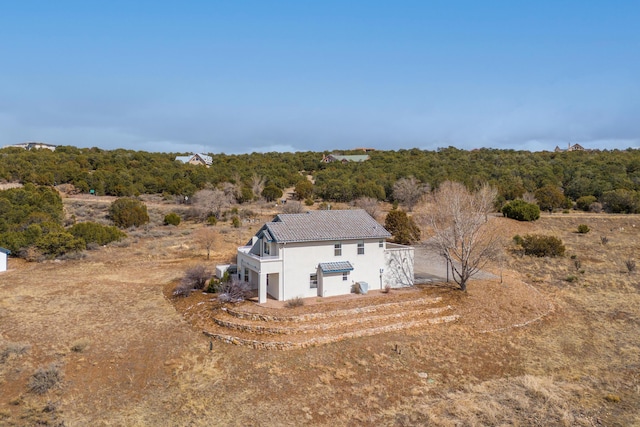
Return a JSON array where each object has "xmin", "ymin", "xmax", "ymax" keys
[{"xmin": 263, "ymin": 209, "xmax": 391, "ymax": 242}]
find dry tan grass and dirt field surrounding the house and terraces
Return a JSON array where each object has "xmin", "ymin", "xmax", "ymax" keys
[{"xmin": 0, "ymin": 198, "xmax": 640, "ymax": 426}]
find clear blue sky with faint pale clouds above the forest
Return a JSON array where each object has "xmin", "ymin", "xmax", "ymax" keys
[{"xmin": 0, "ymin": 0, "xmax": 640, "ymax": 153}]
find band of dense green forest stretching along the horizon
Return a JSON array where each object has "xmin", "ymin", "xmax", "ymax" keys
[{"xmin": 0, "ymin": 146, "xmax": 640, "ymax": 213}]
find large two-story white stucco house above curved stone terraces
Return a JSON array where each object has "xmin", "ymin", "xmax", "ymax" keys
[{"xmin": 237, "ymin": 210, "xmax": 413, "ymax": 303}]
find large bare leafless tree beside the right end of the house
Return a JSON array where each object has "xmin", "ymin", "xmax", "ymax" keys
[{"xmin": 425, "ymin": 181, "xmax": 500, "ymax": 291}]
